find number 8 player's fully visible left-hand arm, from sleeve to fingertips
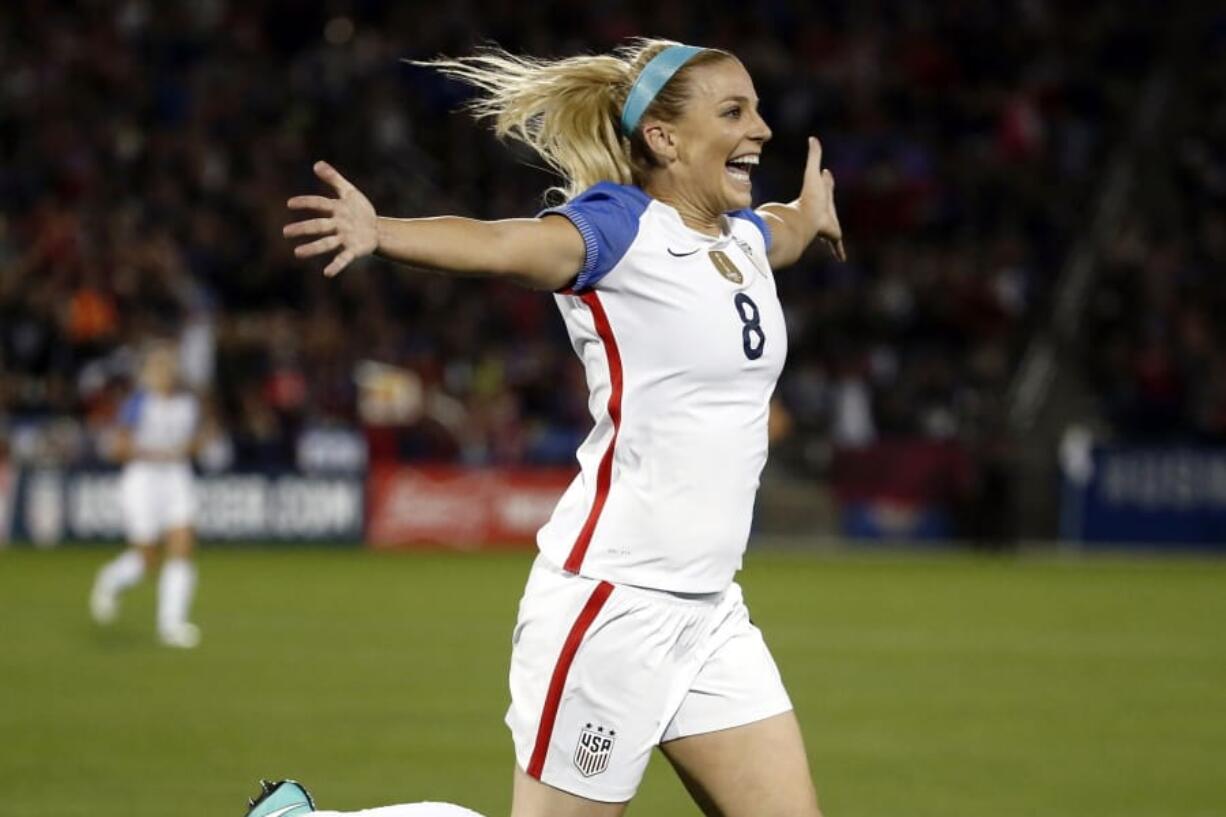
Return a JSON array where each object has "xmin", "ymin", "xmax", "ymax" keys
[{"xmin": 282, "ymin": 162, "xmax": 584, "ymax": 290}]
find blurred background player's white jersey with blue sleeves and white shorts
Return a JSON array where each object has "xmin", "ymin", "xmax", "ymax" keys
[{"xmin": 119, "ymin": 390, "xmax": 200, "ymax": 545}]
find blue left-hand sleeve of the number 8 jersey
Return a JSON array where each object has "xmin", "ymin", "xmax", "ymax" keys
[{"xmin": 541, "ymin": 182, "xmax": 651, "ymax": 291}]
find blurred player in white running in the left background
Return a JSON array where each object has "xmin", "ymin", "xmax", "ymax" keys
[{"xmin": 89, "ymin": 343, "xmax": 202, "ymax": 648}]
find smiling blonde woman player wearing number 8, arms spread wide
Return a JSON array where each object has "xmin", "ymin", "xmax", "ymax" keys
[{"xmin": 284, "ymin": 40, "xmax": 843, "ymax": 817}]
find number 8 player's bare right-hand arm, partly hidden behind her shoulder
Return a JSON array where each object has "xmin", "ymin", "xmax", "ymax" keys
[{"xmin": 758, "ymin": 136, "xmax": 847, "ymax": 269}]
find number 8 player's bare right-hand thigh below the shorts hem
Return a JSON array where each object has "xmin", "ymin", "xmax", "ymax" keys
[{"xmin": 661, "ymin": 712, "xmax": 821, "ymax": 817}]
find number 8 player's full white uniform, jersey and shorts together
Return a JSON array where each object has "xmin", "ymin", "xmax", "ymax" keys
[{"xmin": 508, "ymin": 183, "xmax": 791, "ymax": 802}]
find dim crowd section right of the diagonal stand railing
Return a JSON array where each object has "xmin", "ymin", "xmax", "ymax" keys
[{"xmin": 1083, "ymin": 10, "xmax": 1226, "ymax": 443}]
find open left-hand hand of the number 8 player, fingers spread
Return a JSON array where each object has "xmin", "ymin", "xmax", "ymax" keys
[{"xmin": 281, "ymin": 162, "xmax": 379, "ymax": 277}]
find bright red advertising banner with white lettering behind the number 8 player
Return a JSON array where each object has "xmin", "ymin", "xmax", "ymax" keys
[{"xmin": 367, "ymin": 466, "xmax": 575, "ymax": 550}]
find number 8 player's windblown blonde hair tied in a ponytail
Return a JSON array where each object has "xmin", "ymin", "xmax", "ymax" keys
[{"xmin": 416, "ymin": 38, "xmax": 732, "ymax": 199}]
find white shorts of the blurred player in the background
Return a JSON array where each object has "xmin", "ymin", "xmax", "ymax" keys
[{"xmin": 119, "ymin": 462, "xmax": 196, "ymax": 546}]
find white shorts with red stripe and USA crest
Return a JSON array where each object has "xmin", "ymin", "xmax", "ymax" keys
[{"xmin": 506, "ymin": 549, "xmax": 792, "ymax": 802}]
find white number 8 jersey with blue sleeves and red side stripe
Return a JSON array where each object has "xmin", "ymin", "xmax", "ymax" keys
[{"xmin": 537, "ymin": 182, "xmax": 787, "ymax": 593}]
